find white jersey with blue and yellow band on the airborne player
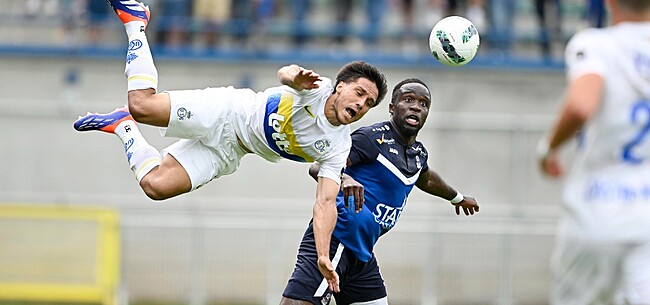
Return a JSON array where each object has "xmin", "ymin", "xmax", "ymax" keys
[{"xmin": 234, "ymin": 77, "xmax": 352, "ymax": 182}]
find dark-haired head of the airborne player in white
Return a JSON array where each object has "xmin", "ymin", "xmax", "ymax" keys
[{"xmin": 332, "ymin": 61, "xmax": 388, "ymax": 125}]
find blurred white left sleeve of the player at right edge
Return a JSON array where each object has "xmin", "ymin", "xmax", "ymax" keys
[{"xmin": 564, "ymin": 29, "xmax": 607, "ymax": 80}]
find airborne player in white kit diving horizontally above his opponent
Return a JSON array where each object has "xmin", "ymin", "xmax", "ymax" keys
[{"xmin": 74, "ymin": 0, "xmax": 387, "ymax": 286}]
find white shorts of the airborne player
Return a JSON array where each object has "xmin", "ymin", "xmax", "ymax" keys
[{"xmin": 161, "ymin": 87, "xmax": 246, "ymax": 190}]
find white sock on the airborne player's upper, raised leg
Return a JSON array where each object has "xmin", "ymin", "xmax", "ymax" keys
[{"xmin": 124, "ymin": 21, "xmax": 158, "ymax": 91}]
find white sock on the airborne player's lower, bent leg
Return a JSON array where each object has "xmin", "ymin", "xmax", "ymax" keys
[{"xmin": 115, "ymin": 120, "xmax": 162, "ymax": 182}]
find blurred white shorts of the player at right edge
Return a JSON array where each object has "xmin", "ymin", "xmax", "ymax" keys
[{"xmin": 550, "ymin": 236, "xmax": 650, "ymax": 305}]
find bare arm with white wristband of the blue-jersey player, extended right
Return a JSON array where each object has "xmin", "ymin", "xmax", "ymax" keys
[{"xmin": 415, "ymin": 169, "xmax": 479, "ymax": 215}]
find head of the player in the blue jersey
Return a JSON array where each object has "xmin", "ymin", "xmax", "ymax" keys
[{"xmin": 388, "ymin": 78, "xmax": 431, "ymax": 138}]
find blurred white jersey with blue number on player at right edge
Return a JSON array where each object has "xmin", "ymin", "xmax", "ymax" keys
[{"xmin": 564, "ymin": 23, "xmax": 650, "ymax": 240}]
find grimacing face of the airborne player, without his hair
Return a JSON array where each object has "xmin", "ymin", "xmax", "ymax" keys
[{"xmin": 334, "ymin": 78, "xmax": 379, "ymax": 125}]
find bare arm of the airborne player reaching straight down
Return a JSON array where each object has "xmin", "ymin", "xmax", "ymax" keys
[{"xmin": 313, "ymin": 177, "xmax": 340, "ymax": 292}]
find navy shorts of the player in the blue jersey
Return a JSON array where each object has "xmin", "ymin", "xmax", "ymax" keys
[{"xmin": 282, "ymin": 223, "xmax": 386, "ymax": 305}]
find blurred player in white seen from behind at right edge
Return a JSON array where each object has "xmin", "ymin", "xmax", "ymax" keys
[{"xmin": 538, "ymin": 0, "xmax": 650, "ymax": 305}]
